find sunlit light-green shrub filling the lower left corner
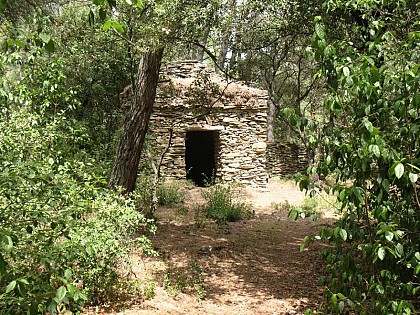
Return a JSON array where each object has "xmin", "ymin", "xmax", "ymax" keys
[{"xmin": 0, "ymin": 110, "xmax": 154, "ymax": 314}]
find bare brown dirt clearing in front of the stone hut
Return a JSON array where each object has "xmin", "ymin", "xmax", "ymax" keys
[{"xmin": 87, "ymin": 180, "xmax": 333, "ymax": 315}]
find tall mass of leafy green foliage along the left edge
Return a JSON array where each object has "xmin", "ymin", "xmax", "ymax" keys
[{"xmin": 0, "ymin": 19, "xmax": 154, "ymax": 314}]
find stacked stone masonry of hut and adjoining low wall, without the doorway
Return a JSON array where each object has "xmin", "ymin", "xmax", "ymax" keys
[{"xmin": 120, "ymin": 61, "xmax": 307, "ymax": 187}]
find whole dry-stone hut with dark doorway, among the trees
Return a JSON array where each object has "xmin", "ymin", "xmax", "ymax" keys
[{"xmin": 134, "ymin": 61, "xmax": 268, "ymax": 187}]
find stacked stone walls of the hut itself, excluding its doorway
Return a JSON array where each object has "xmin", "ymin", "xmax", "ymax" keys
[{"xmin": 125, "ymin": 61, "xmax": 271, "ymax": 187}]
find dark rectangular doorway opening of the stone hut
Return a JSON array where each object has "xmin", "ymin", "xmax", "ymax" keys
[{"xmin": 185, "ymin": 131, "xmax": 217, "ymax": 187}]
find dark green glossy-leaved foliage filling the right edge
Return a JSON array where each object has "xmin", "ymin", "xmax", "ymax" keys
[{"xmin": 300, "ymin": 1, "xmax": 420, "ymax": 314}]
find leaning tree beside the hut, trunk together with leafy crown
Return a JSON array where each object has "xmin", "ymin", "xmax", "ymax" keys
[{"xmin": 88, "ymin": 0, "xmax": 221, "ymax": 194}]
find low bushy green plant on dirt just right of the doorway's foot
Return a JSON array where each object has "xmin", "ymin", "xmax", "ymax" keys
[{"xmin": 202, "ymin": 185, "xmax": 252, "ymax": 224}]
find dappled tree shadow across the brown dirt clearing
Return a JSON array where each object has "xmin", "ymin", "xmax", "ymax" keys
[{"xmin": 149, "ymin": 211, "xmax": 330, "ymax": 314}]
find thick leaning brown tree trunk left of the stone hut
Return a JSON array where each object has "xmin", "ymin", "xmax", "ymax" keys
[{"xmin": 109, "ymin": 48, "xmax": 163, "ymax": 194}]
